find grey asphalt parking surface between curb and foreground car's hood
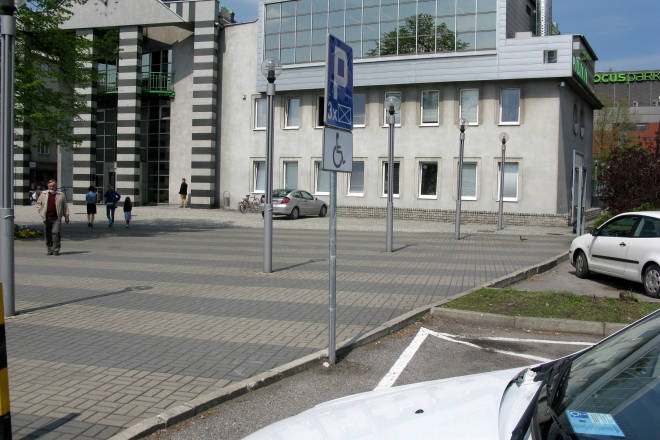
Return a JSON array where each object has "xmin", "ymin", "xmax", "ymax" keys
[{"xmin": 149, "ymin": 315, "xmax": 599, "ymax": 440}]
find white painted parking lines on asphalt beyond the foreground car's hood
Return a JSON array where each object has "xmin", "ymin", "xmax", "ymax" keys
[{"xmin": 374, "ymin": 327, "xmax": 593, "ymax": 390}]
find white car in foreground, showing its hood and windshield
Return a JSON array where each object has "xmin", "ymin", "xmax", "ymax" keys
[{"xmin": 247, "ymin": 311, "xmax": 660, "ymax": 440}]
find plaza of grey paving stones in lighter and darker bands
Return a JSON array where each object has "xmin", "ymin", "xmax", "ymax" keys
[{"xmin": 6, "ymin": 206, "xmax": 572, "ymax": 439}]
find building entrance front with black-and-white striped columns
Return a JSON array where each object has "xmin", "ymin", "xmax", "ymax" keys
[{"xmin": 14, "ymin": 0, "xmax": 233, "ymax": 209}]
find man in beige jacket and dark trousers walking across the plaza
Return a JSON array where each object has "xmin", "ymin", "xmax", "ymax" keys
[{"xmin": 36, "ymin": 179, "xmax": 69, "ymax": 256}]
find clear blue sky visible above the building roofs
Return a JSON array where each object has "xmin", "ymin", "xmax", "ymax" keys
[{"xmin": 220, "ymin": 0, "xmax": 660, "ymax": 71}]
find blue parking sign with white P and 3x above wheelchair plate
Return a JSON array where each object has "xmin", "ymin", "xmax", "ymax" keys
[{"xmin": 324, "ymin": 34, "xmax": 353, "ymax": 131}]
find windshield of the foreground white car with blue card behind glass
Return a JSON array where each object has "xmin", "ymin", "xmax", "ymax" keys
[{"xmin": 537, "ymin": 313, "xmax": 660, "ymax": 439}]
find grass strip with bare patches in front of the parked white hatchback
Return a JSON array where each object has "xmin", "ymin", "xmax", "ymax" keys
[{"xmin": 442, "ymin": 289, "xmax": 660, "ymax": 324}]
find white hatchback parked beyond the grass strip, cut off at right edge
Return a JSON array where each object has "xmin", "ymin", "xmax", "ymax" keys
[{"xmin": 568, "ymin": 211, "xmax": 660, "ymax": 298}]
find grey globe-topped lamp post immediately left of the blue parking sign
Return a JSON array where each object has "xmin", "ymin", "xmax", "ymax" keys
[{"xmin": 261, "ymin": 58, "xmax": 282, "ymax": 273}]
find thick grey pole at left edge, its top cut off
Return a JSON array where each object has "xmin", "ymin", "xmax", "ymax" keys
[{"xmin": 0, "ymin": 0, "xmax": 20, "ymax": 316}]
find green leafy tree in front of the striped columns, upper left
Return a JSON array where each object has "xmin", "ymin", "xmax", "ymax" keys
[{"xmin": 14, "ymin": 0, "xmax": 118, "ymax": 150}]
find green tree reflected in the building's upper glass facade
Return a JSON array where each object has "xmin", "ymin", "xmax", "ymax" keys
[{"xmin": 367, "ymin": 14, "xmax": 469, "ymax": 57}]
